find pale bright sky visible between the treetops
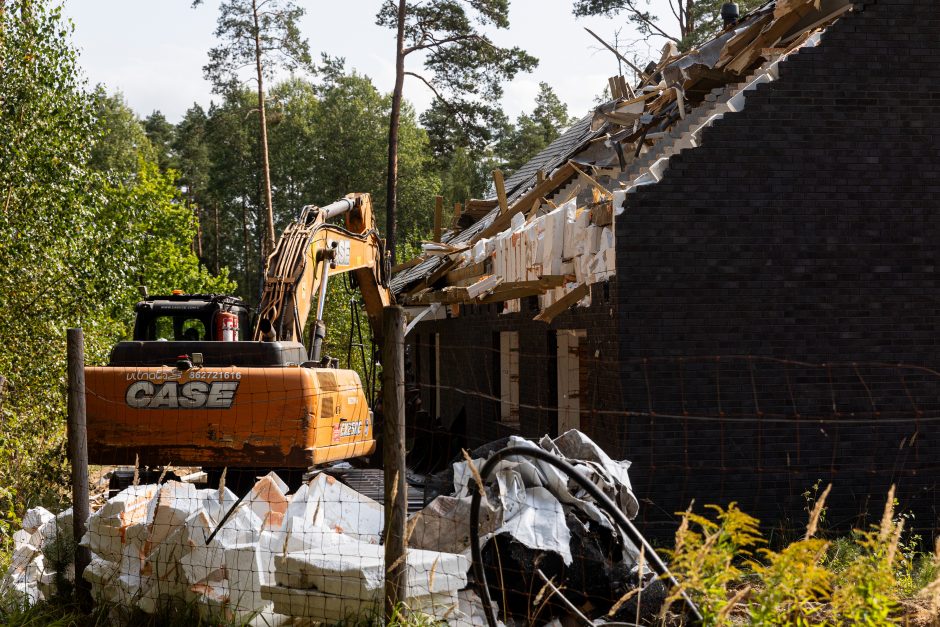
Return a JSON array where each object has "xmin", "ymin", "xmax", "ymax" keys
[{"xmin": 58, "ymin": 0, "xmax": 668, "ymax": 122}]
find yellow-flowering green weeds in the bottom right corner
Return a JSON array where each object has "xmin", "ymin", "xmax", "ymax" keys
[{"xmin": 662, "ymin": 488, "xmax": 940, "ymax": 626}]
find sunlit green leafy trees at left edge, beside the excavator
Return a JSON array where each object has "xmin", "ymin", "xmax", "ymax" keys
[{"xmin": 0, "ymin": 0, "xmax": 232, "ymax": 548}]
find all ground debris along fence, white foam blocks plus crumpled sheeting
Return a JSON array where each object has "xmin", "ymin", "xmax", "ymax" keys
[{"xmin": 0, "ymin": 431, "xmax": 650, "ymax": 625}]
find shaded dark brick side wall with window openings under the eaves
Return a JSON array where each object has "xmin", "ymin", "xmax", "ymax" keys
[{"xmin": 407, "ymin": 281, "xmax": 619, "ymax": 447}]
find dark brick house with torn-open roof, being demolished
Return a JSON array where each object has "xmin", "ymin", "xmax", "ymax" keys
[{"xmin": 393, "ymin": 0, "xmax": 940, "ymax": 535}]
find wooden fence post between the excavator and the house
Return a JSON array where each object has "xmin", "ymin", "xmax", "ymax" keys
[{"xmin": 382, "ymin": 307, "xmax": 408, "ymax": 622}]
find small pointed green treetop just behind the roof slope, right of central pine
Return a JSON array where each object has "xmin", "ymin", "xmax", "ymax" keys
[{"xmin": 497, "ymin": 83, "xmax": 574, "ymax": 172}]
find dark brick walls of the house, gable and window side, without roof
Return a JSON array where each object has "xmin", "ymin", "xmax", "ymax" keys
[{"xmin": 410, "ymin": 0, "xmax": 940, "ymax": 536}]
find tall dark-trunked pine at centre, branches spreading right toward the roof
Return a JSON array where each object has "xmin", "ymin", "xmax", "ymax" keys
[{"xmin": 376, "ymin": 0, "xmax": 538, "ymax": 262}]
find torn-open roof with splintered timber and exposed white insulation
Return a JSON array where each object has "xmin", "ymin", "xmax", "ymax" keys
[{"xmin": 392, "ymin": 0, "xmax": 853, "ymax": 322}]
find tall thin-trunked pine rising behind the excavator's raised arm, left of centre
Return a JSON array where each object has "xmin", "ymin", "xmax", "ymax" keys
[{"xmin": 193, "ymin": 0, "xmax": 313, "ymax": 262}]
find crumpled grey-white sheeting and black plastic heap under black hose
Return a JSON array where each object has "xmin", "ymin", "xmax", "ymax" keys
[{"xmin": 409, "ymin": 430, "xmax": 665, "ymax": 623}]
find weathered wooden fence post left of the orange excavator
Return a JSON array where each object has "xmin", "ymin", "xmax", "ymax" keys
[{"xmin": 66, "ymin": 328, "xmax": 91, "ymax": 604}]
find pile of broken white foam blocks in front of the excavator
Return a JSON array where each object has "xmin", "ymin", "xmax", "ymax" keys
[{"xmin": 2, "ymin": 473, "xmax": 470, "ymax": 625}]
